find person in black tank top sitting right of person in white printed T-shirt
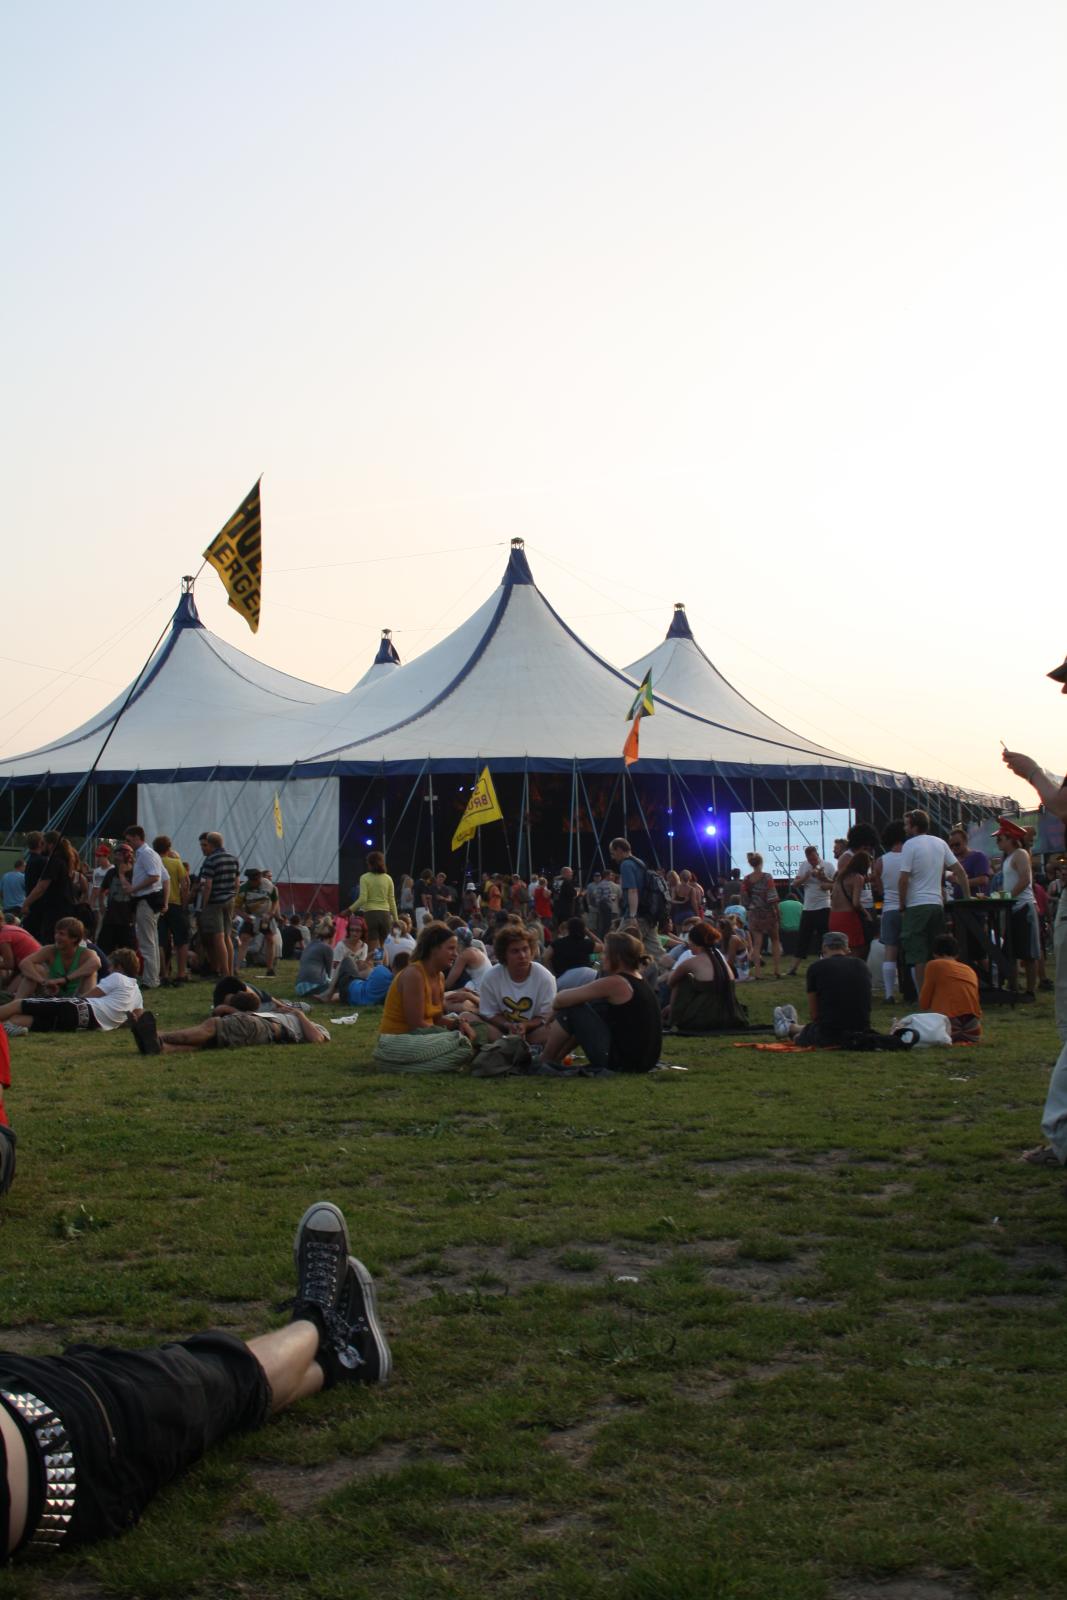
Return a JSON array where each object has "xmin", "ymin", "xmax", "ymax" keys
[{"xmin": 537, "ymin": 933, "xmax": 662, "ymax": 1074}]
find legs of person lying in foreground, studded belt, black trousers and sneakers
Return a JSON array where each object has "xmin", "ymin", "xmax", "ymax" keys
[{"xmin": 0, "ymin": 1200, "xmax": 392, "ymax": 1554}]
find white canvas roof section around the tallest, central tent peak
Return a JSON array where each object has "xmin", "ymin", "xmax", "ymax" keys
[{"xmin": 286, "ymin": 539, "xmax": 909, "ymax": 787}]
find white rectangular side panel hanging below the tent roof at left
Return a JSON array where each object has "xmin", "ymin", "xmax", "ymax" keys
[{"xmin": 138, "ymin": 778, "xmax": 341, "ymax": 885}]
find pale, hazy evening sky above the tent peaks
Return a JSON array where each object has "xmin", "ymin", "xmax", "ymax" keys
[{"xmin": 0, "ymin": 0, "xmax": 1067, "ymax": 803}]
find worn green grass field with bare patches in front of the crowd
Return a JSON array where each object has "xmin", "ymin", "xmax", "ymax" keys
[{"xmin": 0, "ymin": 968, "xmax": 1067, "ymax": 1600}]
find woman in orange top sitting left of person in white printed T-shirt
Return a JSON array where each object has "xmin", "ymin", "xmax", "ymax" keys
[{"xmin": 374, "ymin": 922, "xmax": 475, "ymax": 1072}]
